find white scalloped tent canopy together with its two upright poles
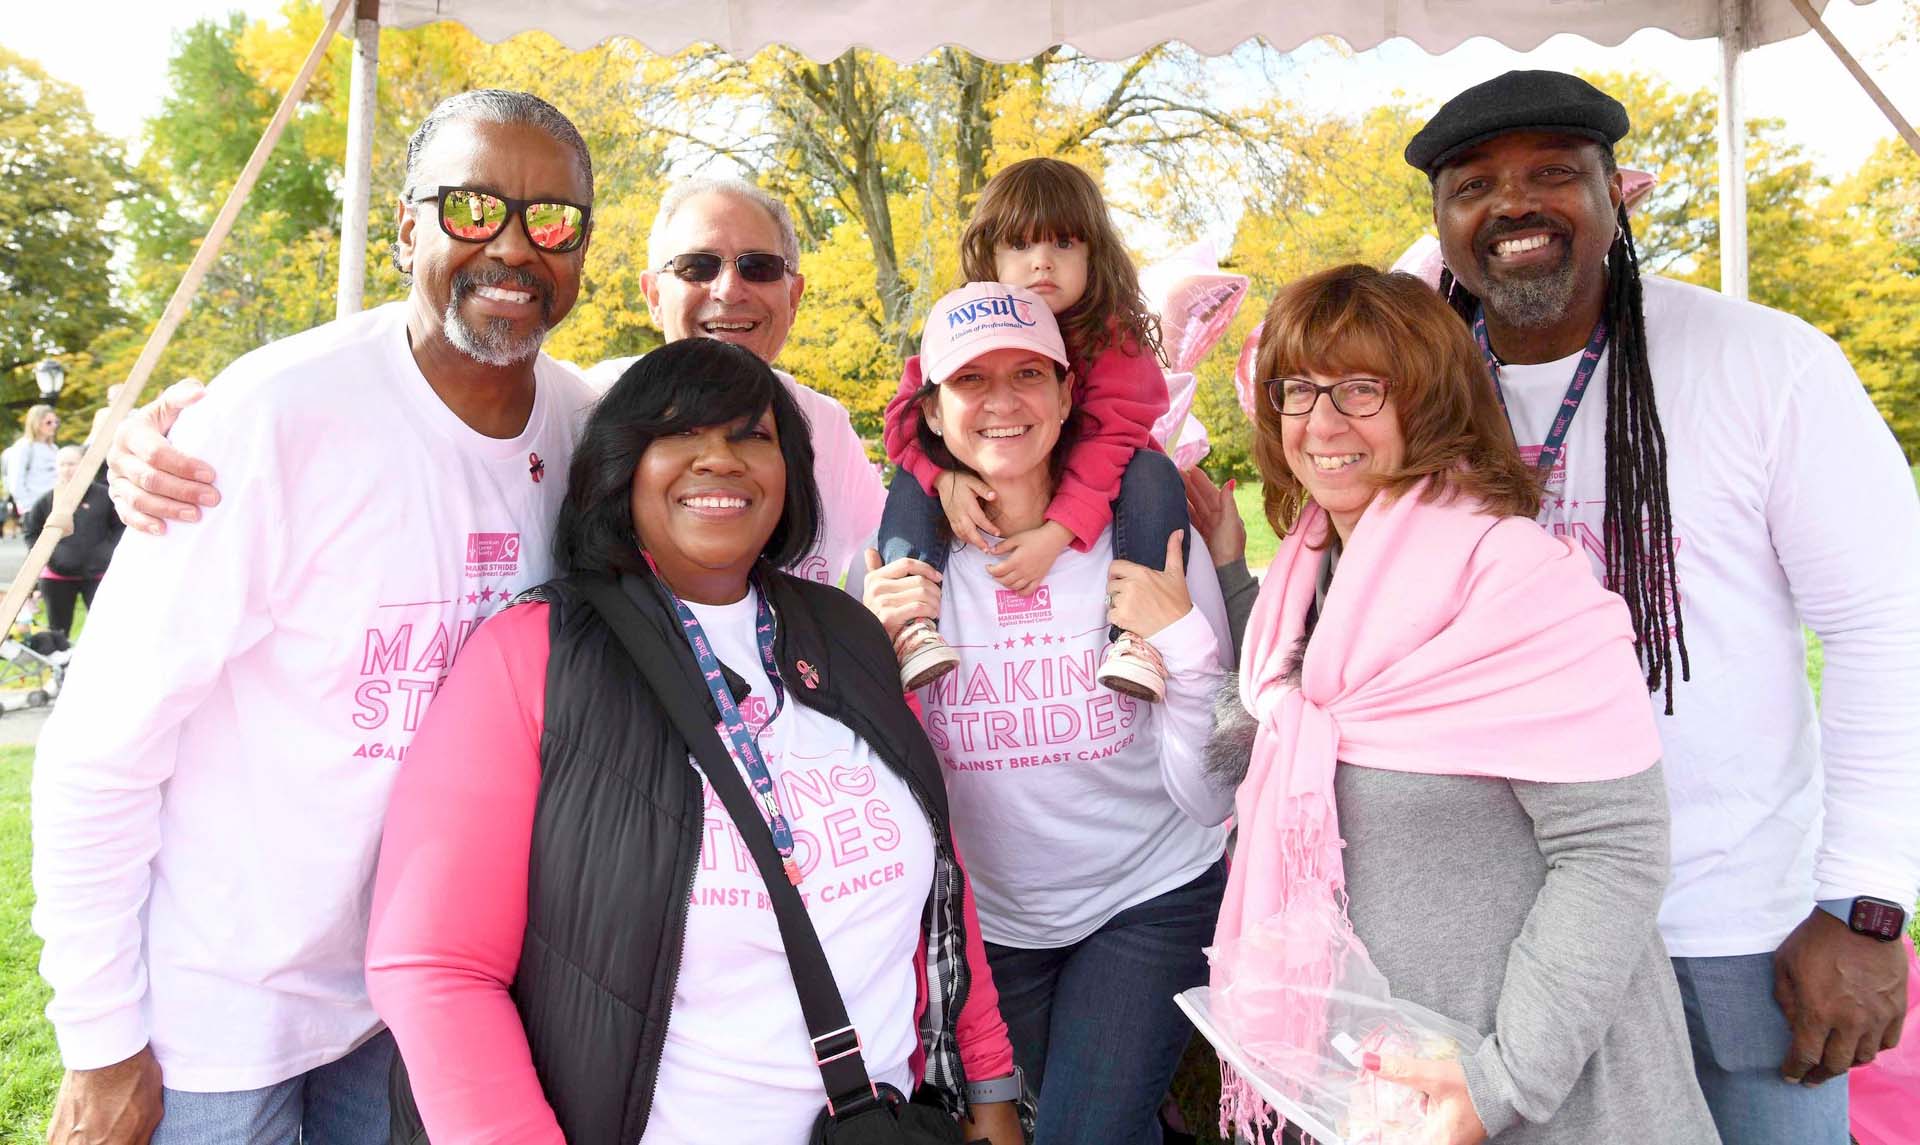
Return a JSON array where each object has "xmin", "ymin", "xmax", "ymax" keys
[{"xmin": 338, "ymin": 0, "xmax": 1889, "ymax": 317}]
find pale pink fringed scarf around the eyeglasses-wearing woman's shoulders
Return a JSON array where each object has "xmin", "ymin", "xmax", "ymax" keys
[{"xmin": 1212, "ymin": 486, "xmax": 1661, "ymax": 1132}]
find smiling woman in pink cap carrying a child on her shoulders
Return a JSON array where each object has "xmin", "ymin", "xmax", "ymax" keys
[{"xmin": 849, "ymin": 282, "xmax": 1231, "ymax": 1145}]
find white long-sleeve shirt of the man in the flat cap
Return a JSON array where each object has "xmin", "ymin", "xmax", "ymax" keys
[{"xmin": 1500, "ymin": 279, "xmax": 1920, "ymax": 957}]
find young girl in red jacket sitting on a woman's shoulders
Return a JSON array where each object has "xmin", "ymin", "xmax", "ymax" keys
[{"xmin": 879, "ymin": 159, "xmax": 1187, "ymax": 701}]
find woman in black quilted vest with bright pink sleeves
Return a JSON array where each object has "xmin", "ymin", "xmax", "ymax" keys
[{"xmin": 367, "ymin": 338, "xmax": 1020, "ymax": 1145}]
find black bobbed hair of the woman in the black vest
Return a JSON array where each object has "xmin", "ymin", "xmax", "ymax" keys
[{"xmin": 553, "ymin": 338, "xmax": 820, "ymax": 574}]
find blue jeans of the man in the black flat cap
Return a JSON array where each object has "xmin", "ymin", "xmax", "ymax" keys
[{"xmin": 1672, "ymin": 955, "xmax": 1847, "ymax": 1145}]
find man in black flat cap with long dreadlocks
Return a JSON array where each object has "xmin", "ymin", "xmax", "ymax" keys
[{"xmin": 1405, "ymin": 71, "xmax": 1920, "ymax": 1145}]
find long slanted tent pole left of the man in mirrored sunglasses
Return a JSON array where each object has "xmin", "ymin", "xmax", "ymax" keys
[{"xmin": 0, "ymin": 0, "xmax": 353, "ymax": 634}]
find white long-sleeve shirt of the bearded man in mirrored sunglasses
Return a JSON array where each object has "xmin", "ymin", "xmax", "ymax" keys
[{"xmin": 33, "ymin": 304, "xmax": 591, "ymax": 1091}]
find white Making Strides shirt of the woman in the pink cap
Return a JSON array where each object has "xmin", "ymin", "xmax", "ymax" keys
[{"xmin": 847, "ymin": 528, "xmax": 1233, "ymax": 949}]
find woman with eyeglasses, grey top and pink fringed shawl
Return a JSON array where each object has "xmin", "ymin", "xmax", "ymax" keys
[{"xmin": 1210, "ymin": 265, "xmax": 1718, "ymax": 1145}]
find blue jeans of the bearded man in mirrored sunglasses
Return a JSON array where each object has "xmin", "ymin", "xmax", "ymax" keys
[{"xmin": 152, "ymin": 1030, "xmax": 394, "ymax": 1145}]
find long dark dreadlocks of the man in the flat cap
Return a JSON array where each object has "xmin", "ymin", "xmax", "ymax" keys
[{"xmin": 1440, "ymin": 169, "xmax": 1692, "ymax": 715}]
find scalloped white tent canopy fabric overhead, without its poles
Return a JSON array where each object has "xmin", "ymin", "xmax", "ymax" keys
[{"xmin": 380, "ymin": 0, "xmax": 1859, "ymax": 61}]
